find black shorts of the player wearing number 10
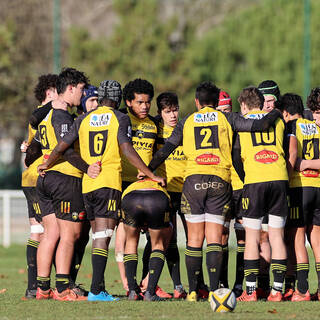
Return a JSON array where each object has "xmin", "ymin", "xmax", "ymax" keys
[{"xmin": 241, "ymin": 181, "xmax": 288, "ymax": 219}]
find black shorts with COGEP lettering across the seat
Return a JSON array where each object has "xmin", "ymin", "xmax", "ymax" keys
[{"xmin": 181, "ymin": 174, "xmax": 232, "ymax": 218}]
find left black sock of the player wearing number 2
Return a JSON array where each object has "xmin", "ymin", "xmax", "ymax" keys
[{"xmin": 185, "ymin": 246, "xmax": 202, "ymax": 293}]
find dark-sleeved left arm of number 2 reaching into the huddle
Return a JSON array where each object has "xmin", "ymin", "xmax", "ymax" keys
[{"xmin": 148, "ymin": 118, "xmax": 186, "ymax": 171}]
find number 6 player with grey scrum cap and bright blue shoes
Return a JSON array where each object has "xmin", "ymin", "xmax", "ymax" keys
[{"xmin": 38, "ymin": 80, "xmax": 165, "ymax": 301}]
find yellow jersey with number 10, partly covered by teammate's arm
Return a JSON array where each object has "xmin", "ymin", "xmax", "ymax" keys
[{"xmin": 239, "ymin": 110, "xmax": 288, "ymax": 184}]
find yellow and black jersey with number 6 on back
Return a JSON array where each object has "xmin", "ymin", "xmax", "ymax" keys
[{"xmin": 63, "ymin": 106, "xmax": 131, "ymax": 193}]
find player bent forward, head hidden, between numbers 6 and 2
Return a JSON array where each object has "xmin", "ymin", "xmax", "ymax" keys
[{"xmin": 121, "ymin": 179, "xmax": 172, "ymax": 301}]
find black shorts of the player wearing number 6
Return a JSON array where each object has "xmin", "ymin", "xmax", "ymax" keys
[{"xmin": 83, "ymin": 188, "xmax": 121, "ymax": 220}]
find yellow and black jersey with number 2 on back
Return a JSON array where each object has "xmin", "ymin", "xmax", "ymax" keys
[{"xmin": 161, "ymin": 107, "xmax": 233, "ymax": 182}]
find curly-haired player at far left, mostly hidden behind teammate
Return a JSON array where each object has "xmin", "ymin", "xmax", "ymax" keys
[{"xmin": 21, "ymin": 74, "xmax": 58, "ymax": 299}]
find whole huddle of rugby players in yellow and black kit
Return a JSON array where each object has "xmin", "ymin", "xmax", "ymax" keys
[{"xmin": 21, "ymin": 68, "xmax": 320, "ymax": 301}]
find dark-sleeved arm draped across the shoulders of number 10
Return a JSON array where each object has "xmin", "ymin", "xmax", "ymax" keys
[{"xmin": 224, "ymin": 109, "xmax": 281, "ymax": 132}]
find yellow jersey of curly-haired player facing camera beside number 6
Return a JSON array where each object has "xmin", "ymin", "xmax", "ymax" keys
[{"xmin": 122, "ymin": 110, "xmax": 158, "ymax": 182}]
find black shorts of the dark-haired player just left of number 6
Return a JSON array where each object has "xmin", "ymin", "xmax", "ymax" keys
[{"xmin": 37, "ymin": 171, "xmax": 86, "ymax": 222}]
